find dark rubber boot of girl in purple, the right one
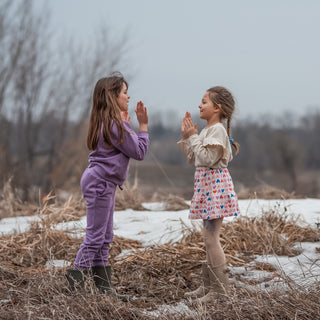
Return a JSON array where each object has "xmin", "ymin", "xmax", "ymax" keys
[{"xmin": 92, "ymin": 266, "xmax": 129, "ymax": 302}]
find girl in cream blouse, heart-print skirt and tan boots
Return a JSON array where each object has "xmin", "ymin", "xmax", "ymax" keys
[{"xmin": 178, "ymin": 86, "xmax": 239, "ymax": 303}]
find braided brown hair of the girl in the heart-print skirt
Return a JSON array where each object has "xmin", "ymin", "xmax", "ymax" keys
[{"xmin": 207, "ymin": 86, "xmax": 240, "ymax": 154}]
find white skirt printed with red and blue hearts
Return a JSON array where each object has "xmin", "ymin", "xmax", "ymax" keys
[{"xmin": 189, "ymin": 167, "xmax": 240, "ymax": 220}]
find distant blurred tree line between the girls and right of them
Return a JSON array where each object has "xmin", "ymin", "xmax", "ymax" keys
[{"xmin": 151, "ymin": 108, "xmax": 320, "ymax": 196}]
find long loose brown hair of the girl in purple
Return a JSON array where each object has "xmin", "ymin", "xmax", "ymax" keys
[{"xmin": 87, "ymin": 72, "xmax": 128, "ymax": 150}]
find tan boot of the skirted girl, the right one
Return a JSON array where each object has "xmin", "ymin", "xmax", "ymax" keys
[{"xmin": 199, "ymin": 263, "xmax": 230, "ymax": 304}]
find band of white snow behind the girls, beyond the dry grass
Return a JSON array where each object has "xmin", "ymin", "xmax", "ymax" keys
[{"xmin": 0, "ymin": 199, "xmax": 320, "ymax": 240}]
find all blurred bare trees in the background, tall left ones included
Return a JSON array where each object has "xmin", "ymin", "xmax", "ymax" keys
[{"xmin": 0, "ymin": 0, "xmax": 320, "ymax": 200}]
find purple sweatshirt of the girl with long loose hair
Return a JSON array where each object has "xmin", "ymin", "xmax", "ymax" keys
[{"xmin": 89, "ymin": 120, "xmax": 149, "ymax": 186}]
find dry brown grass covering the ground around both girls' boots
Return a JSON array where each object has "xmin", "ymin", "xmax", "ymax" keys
[{"xmin": 0, "ymin": 181, "xmax": 320, "ymax": 320}]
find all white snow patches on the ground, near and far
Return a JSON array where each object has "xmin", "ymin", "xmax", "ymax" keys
[{"xmin": 0, "ymin": 199, "xmax": 320, "ymax": 285}]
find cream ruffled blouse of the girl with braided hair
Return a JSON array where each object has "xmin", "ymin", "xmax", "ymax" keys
[{"xmin": 178, "ymin": 122, "xmax": 232, "ymax": 169}]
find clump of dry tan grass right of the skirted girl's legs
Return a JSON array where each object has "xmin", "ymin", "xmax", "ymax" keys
[{"xmin": 221, "ymin": 209, "xmax": 320, "ymax": 257}]
